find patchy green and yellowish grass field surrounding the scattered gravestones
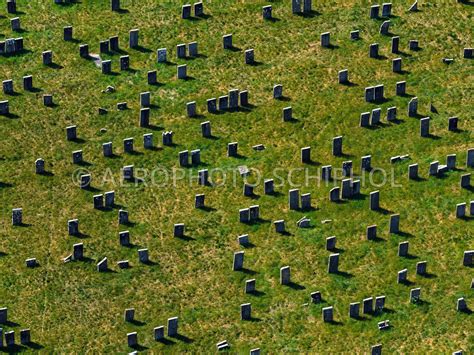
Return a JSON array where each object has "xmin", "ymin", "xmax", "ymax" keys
[{"xmin": 0, "ymin": 0, "xmax": 474, "ymax": 353}]
